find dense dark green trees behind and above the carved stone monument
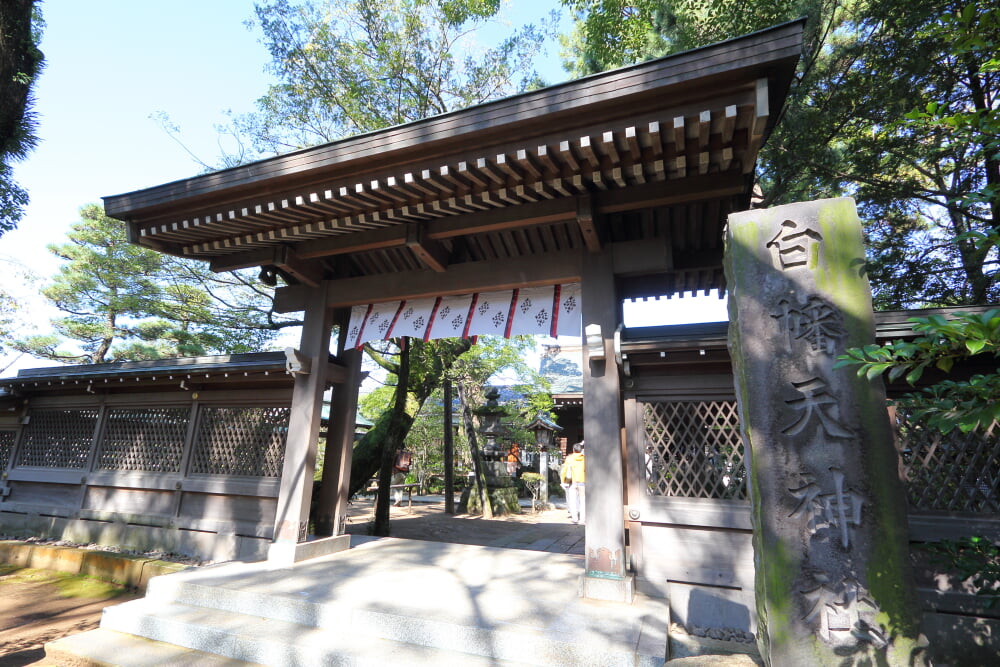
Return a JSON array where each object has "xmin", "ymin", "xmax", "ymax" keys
[{"xmin": 760, "ymin": 0, "xmax": 1000, "ymax": 309}]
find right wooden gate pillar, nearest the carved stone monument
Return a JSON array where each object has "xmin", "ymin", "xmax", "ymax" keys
[{"xmin": 581, "ymin": 249, "xmax": 633, "ymax": 602}]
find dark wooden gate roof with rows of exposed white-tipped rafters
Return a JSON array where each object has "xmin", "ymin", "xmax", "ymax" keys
[{"xmin": 104, "ymin": 21, "xmax": 803, "ymax": 310}]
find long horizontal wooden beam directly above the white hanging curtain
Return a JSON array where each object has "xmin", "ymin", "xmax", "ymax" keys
[{"xmin": 274, "ymin": 251, "xmax": 583, "ymax": 313}]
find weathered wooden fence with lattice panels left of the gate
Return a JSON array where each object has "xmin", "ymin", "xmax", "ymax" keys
[{"xmin": 0, "ymin": 389, "xmax": 291, "ymax": 559}]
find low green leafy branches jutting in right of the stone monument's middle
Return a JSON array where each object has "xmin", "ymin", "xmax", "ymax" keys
[{"xmin": 834, "ymin": 308, "xmax": 1000, "ymax": 433}]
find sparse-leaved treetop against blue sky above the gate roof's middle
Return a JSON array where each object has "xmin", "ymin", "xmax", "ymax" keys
[{"xmin": 233, "ymin": 0, "xmax": 548, "ymax": 154}]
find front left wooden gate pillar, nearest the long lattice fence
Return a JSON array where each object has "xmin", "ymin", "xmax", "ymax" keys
[{"xmin": 268, "ymin": 283, "xmax": 331, "ymax": 562}]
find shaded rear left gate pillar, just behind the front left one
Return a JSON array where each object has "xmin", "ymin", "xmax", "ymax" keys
[{"xmin": 315, "ymin": 308, "xmax": 362, "ymax": 535}]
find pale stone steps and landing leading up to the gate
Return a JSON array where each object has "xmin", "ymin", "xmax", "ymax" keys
[{"xmin": 47, "ymin": 540, "xmax": 669, "ymax": 667}]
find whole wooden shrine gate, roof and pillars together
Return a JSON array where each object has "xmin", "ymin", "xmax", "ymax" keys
[{"xmin": 104, "ymin": 21, "xmax": 804, "ymax": 600}]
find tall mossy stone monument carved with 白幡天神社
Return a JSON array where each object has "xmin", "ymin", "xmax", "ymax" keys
[{"xmin": 726, "ymin": 199, "xmax": 922, "ymax": 667}]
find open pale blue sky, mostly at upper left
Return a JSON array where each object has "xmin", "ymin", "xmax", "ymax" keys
[{"xmin": 0, "ymin": 0, "xmax": 717, "ymax": 374}]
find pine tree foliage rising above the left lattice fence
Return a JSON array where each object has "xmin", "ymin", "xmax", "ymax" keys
[{"xmin": 13, "ymin": 204, "xmax": 295, "ymax": 363}]
